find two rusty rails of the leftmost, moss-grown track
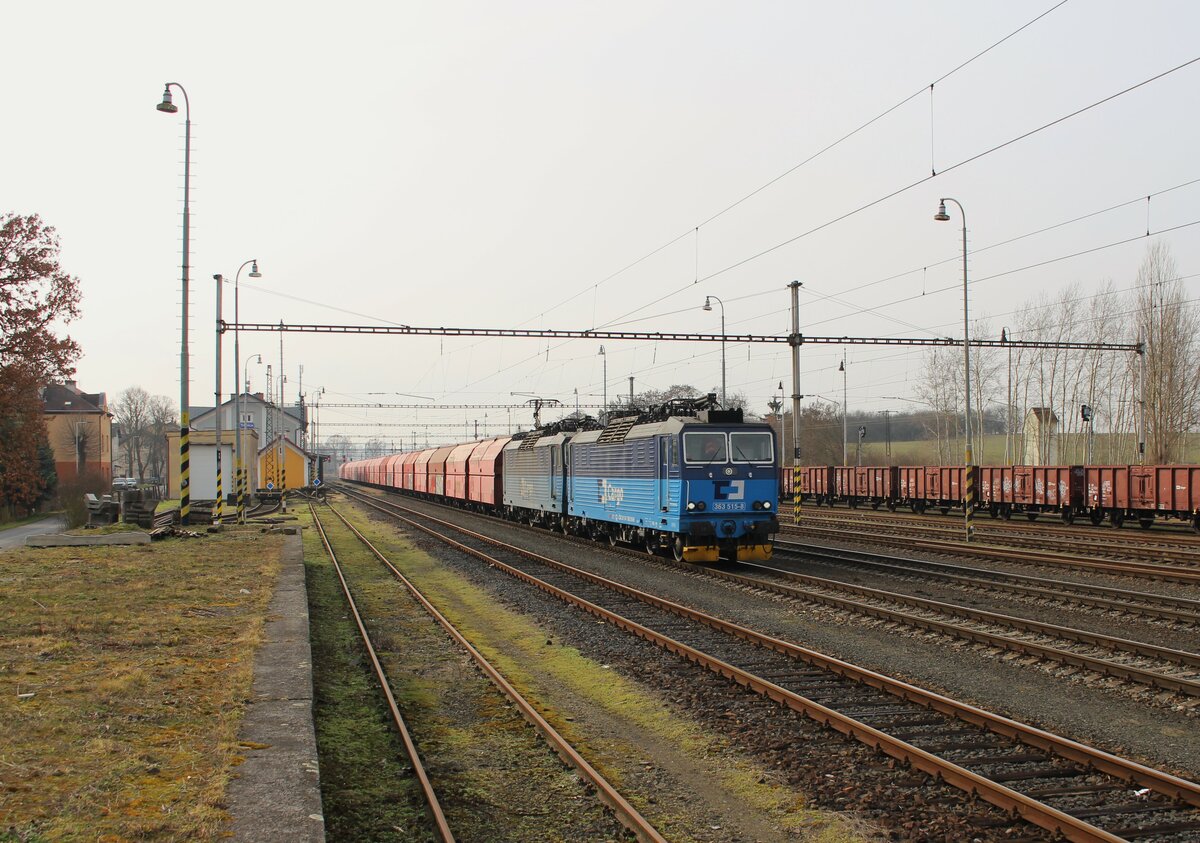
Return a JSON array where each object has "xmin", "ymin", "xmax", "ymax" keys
[{"xmin": 308, "ymin": 502, "xmax": 666, "ymax": 843}]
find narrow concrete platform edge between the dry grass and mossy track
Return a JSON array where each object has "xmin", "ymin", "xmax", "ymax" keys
[{"xmin": 226, "ymin": 536, "xmax": 325, "ymax": 843}]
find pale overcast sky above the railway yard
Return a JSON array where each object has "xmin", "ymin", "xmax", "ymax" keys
[{"xmin": 0, "ymin": 0, "xmax": 1200, "ymax": 443}]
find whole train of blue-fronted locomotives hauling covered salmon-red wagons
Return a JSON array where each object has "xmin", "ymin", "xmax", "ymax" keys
[{"xmin": 338, "ymin": 395, "xmax": 780, "ymax": 562}]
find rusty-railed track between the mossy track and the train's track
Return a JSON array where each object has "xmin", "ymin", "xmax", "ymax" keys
[{"xmin": 336, "ymin": 492, "xmax": 1200, "ymax": 843}]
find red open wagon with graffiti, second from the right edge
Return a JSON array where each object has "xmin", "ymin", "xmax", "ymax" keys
[{"xmin": 978, "ymin": 466, "xmax": 1086, "ymax": 524}]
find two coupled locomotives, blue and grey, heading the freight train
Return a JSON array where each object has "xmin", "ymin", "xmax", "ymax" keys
[{"xmin": 504, "ymin": 395, "xmax": 779, "ymax": 562}]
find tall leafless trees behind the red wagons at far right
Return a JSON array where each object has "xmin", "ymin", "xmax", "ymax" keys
[{"xmin": 918, "ymin": 243, "xmax": 1200, "ymax": 464}]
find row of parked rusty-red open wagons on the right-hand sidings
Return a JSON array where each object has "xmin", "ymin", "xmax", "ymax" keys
[{"xmin": 780, "ymin": 465, "xmax": 1200, "ymax": 533}]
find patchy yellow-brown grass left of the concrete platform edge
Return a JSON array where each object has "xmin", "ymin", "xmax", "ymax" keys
[{"xmin": 0, "ymin": 536, "xmax": 282, "ymax": 841}]
